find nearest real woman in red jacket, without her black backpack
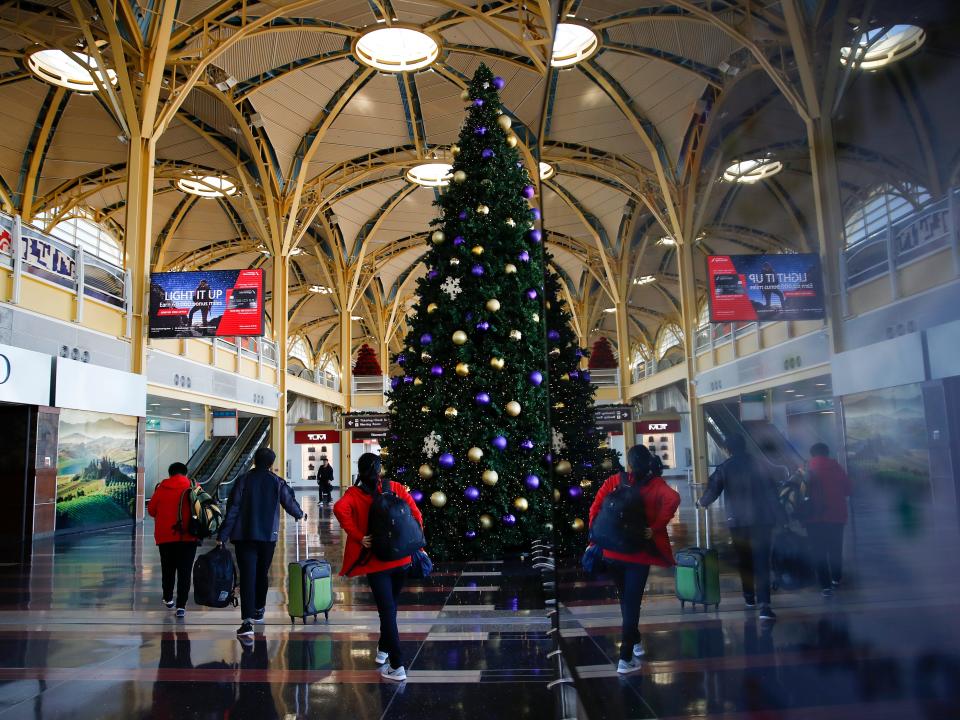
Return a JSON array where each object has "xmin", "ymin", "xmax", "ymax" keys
[{"xmin": 333, "ymin": 453, "xmax": 423, "ymax": 682}]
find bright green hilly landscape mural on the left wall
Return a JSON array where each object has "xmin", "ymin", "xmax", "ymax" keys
[{"xmin": 57, "ymin": 409, "xmax": 137, "ymax": 531}]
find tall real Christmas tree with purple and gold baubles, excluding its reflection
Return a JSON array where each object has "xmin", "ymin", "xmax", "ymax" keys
[{"xmin": 384, "ymin": 65, "xmax": 553, "ymax": 559}]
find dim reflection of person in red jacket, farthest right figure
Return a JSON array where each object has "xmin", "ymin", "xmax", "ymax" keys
[{"xmin": 807, "ymin": 443, "xmax": 853, "ymax": 597}]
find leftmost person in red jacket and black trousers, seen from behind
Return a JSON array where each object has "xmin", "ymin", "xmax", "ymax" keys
[{"xmin": 147, "ymin": 463, "xmax": 200, "ymax": 617}]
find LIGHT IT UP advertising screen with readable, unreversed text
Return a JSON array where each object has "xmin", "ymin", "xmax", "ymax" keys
[{"xmin": 150, "ymin": 269, "xmax": 264, "ymax": 340}]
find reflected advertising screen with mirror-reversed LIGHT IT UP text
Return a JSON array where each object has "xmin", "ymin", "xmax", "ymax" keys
[{"xmin": 707, "ymin": 253, "xmax": 824, "ymax": 322}]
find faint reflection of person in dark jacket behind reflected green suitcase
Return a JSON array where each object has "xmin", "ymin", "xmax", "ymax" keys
[{"xmin": 697, "ymin": 435, "xmax": 786, "ymax": 620}]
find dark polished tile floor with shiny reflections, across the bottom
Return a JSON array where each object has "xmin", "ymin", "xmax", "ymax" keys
[{"xmin": 0, "ymin": 486, "xmax": 960, "ymax": 720}]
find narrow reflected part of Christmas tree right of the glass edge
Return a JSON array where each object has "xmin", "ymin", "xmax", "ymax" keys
[{"xmin": 544, "ymin": 264, "xmax": 620, "ymax": 557}]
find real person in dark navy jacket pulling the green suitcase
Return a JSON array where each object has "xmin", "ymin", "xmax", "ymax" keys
[{"xmin": 217, "ymin": 447, "xmax": 307, "ymax": 637}]
